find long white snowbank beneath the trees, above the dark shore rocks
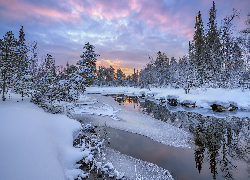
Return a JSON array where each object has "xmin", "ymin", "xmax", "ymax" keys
[{"xmin": 86, "ymin": 87, "xmax": 250, "ymax": 110}]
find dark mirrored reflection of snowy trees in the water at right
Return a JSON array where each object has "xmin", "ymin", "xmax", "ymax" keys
[{"xmin": 108, "ymin": 95, "xmax": 250, "ymax": 179}]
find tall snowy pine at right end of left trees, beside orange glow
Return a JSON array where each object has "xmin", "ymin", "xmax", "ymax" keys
[{"xmin": 76, "ymin": 42, "xmax": 99, "ymax": 86}]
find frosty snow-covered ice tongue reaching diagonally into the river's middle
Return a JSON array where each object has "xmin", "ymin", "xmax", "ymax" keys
[{"xmin": 72, "ymin": 94, "xmax": 191, "ymax": 148}]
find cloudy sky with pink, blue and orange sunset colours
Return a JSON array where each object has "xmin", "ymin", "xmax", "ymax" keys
[{"xmin": 0, "ymin": 0, "xmax": 250, "ymax": 75}]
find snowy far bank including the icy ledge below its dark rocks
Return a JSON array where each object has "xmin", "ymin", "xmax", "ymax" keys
[{"xmin": 85, "ymin": 87, "xmax": 250, "ymax": 117}]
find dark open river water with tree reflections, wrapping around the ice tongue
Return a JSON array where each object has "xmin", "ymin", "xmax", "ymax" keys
[{"xmin": 102, "ymin": 95, "xmax": 250, "ymax": 180}]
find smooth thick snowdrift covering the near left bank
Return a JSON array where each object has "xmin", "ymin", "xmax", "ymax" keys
[{"xmin": 0, "ymin": 95, "xmax": 86, "ymax": 180}]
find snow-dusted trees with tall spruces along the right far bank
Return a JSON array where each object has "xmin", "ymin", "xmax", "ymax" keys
[{"xmin": 139, "ymin": 2, "xmax": 250, "ymax": 93}]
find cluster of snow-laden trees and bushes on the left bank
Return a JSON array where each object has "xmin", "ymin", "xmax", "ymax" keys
[{"xmin": 0, "ymin": 26, "xmax": 99, "ymax": 112}]
